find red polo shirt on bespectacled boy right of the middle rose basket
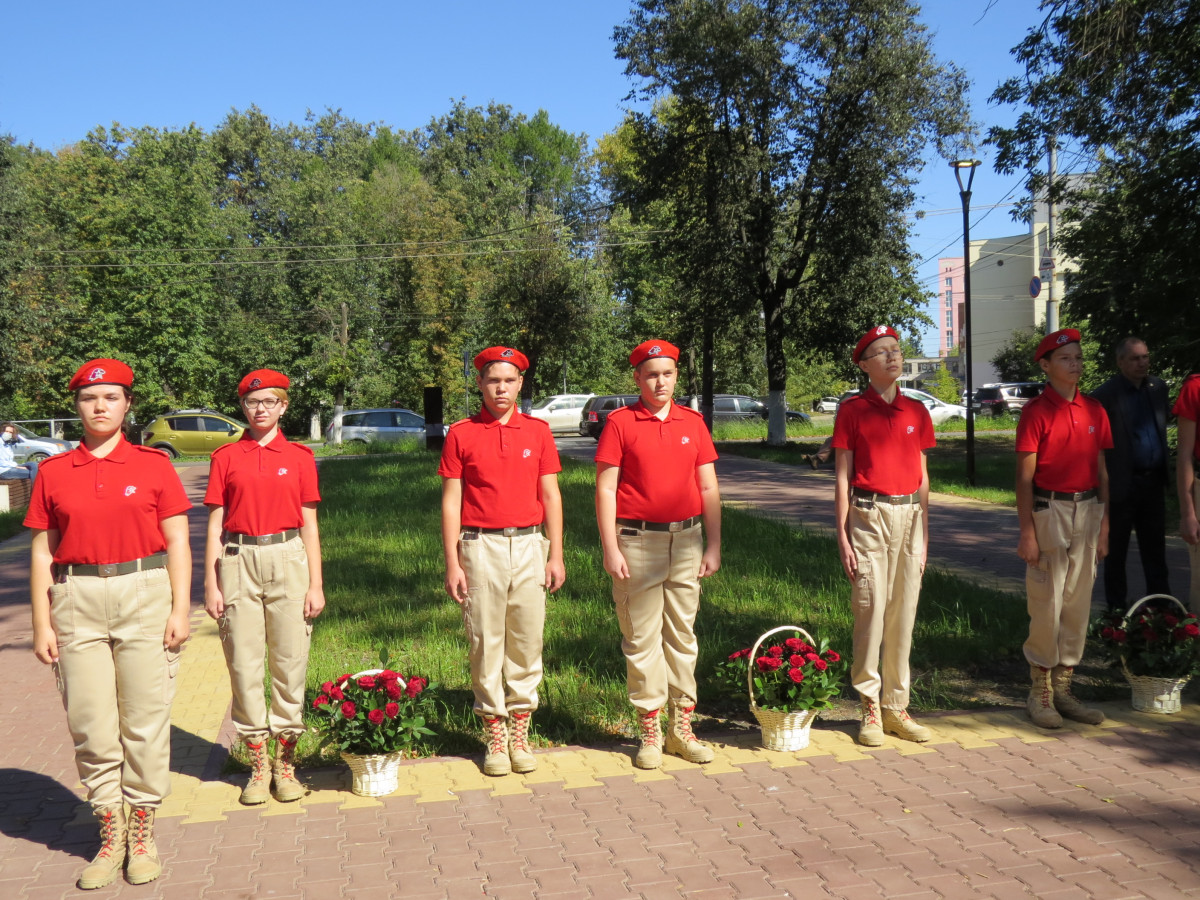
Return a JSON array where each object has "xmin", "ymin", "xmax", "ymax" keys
[{"xmin": 833, "ymin": 385, "xmax": 937, "ymax": 497}]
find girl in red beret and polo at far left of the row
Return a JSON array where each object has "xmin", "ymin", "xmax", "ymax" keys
[{"xmin": 25, "ymin": 359, "xmax": 192, "ymax": 890}]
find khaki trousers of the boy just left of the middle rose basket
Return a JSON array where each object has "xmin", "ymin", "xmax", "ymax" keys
[{"xmin": 612, "ymin": 526, "xmax": 704, "ymax": 713}]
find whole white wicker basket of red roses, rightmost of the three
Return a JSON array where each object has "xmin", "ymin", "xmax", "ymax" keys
[{"xmin": 1092, "ymin": 594, "xmax": 1200, "ymax": 715}]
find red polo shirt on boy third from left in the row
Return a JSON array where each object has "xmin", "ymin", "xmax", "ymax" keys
[{"xmin": 438, "ymin": 407, "xmax": 563, "ymax": 528}]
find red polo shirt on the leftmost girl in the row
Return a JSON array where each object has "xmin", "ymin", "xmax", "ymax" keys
[{"xmin": 25, "ymin": 438, "xmax": 192, "ymax": 565}]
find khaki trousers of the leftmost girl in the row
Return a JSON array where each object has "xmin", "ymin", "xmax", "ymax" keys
[{"xmin": 50, "ymin": 569, "xmax": 180, "ymax": 808}]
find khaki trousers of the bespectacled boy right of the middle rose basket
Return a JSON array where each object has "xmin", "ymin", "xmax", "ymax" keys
[{"xmin": 850, "ymin": 499, "xmax": 925, "ymax": 709}]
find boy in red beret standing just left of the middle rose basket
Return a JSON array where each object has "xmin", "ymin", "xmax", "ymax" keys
[{"xmin": 595, "ymin": 341, "xmax": 721, "ymax": 769}]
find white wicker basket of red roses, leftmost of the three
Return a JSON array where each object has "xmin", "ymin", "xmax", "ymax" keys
[{"xmin": 312, "ymin": 650, "xmax": 433, "ymax": 797}]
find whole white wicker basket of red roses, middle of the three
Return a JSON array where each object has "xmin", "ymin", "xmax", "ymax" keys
[{"xmin": 734, "ymin": 625, "xmax": 846, "ymax": 751}]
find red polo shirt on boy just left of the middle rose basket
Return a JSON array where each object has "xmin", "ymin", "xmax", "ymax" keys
[{"xmin": 596, "ymin": 401, "xmax": 716, "ymax": 522}]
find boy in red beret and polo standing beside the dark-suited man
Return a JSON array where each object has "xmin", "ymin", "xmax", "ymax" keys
[{"xmin": 1016, "ymin": 328, "xmax": 1112, "ymax": 728}]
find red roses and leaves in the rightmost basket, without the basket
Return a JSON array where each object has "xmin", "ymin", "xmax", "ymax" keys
[{"xmin": 1091, "ymin": 598, "xmax": 1200, "ymax": 678}]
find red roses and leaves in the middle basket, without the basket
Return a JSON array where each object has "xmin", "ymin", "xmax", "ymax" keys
[{"xmin": 718, "ymin": 635, "xmax": 847, "ymax": 713}]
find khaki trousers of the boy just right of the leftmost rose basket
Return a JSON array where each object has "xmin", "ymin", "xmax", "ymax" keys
[{"xmin": 458, "ymin": 533, "xmax": 550, "ymax": 716}]
